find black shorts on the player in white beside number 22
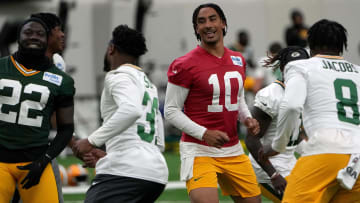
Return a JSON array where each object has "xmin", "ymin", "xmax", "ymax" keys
[{"xmin": 85, "ymin": 174, "xmax": 165, "ymax": 203}]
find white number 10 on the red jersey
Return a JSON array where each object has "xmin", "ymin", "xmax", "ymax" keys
[{"xmin": 208, "ymin": 71, "xmax": 242, "ymax": 112}]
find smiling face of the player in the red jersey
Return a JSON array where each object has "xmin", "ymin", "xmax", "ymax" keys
[{"xmin": 196, "ymin": 7, "xmax": 226, "ymax": 45}]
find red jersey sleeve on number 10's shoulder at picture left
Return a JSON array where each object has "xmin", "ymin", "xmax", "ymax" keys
[{"xmin": 167, "ymin": 59, "xmax": 192, "ymax": 89}]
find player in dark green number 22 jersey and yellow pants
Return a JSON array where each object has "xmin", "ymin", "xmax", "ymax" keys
[{"xmin": 0, "ymin": 18, "xmax": 75, "ymax": 202}]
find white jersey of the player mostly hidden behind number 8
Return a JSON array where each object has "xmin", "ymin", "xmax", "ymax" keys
[{"xmin": 249, "ymin": 81, "xmax": 301, "ymax": 183}]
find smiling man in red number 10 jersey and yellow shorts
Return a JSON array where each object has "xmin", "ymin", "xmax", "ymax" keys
[{"xmin": 165, "ymin": 3, "xmax": 261, "ymax": 203}]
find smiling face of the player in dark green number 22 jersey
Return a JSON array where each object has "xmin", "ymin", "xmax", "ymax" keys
[{"xmin": 19, "ymin": 21, "xmax": 47, "ymax": 50}]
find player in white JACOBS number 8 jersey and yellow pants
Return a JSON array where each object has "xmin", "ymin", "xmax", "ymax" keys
[{"xmin": 265, "ymin": 19, "xmax": 360, "ymax": 202}]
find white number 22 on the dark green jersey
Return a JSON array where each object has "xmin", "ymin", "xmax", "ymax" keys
[{"xmin": 0, "ymin": 79, "xmax": 50, "ymax": 127}]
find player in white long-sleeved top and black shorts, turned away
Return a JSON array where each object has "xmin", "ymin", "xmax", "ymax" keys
[{"xmin": 73, "ymin": 25, "xmax": 168, "ymax": 203}]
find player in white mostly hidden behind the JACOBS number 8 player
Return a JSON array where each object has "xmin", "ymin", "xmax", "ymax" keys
[{"xmin": 245, "ymin": 46, "xmax": 309, "ymax": 202}]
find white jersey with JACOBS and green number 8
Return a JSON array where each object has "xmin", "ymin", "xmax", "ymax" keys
[{"xmin": 273, "ymin": 55, "xmax": 360, "ymax": 156}]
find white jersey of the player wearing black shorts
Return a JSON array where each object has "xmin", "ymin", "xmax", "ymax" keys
[{"xmin": 88, "ymin": 64, "xmax": 168, "ymax": 184}]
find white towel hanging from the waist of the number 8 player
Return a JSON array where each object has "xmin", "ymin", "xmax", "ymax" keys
[{"xmin": 336, "ymin": 154, "xmax": 360, "ymax": 190}]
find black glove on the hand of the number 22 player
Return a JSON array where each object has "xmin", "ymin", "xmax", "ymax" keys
[{"xmin": 18, "ymin": 155, "xmax": 51, "ymax": 189}]
